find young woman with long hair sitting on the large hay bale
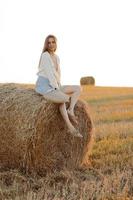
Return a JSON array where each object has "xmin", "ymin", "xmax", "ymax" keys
[{"xmin": 35, "ymin": 35, "xmax": 82, "ymax": 137}]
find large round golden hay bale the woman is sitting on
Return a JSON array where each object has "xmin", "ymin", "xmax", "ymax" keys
[{"xmin": 0, "ymin": 83, "xmax": 94, "ymax": 174}]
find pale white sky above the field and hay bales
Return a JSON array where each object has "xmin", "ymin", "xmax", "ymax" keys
[{"xmin": 0, "ymin": 0, "xmax": 133, "ymax": 87}]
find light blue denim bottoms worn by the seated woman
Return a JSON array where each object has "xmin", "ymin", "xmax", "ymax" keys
[{"xmin": 35, "ymin": 76, "xmax": 55, "ymax": 95}]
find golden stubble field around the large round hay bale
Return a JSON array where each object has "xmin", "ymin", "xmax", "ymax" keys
[{"xmin": 0, "ymin": 86, "xmax": 133, "ymax": 200}]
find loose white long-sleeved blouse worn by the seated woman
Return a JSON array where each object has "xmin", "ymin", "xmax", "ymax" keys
[{"xmin": 37, "ymin": 51, "xmax": 61, "ymax": 88}]
